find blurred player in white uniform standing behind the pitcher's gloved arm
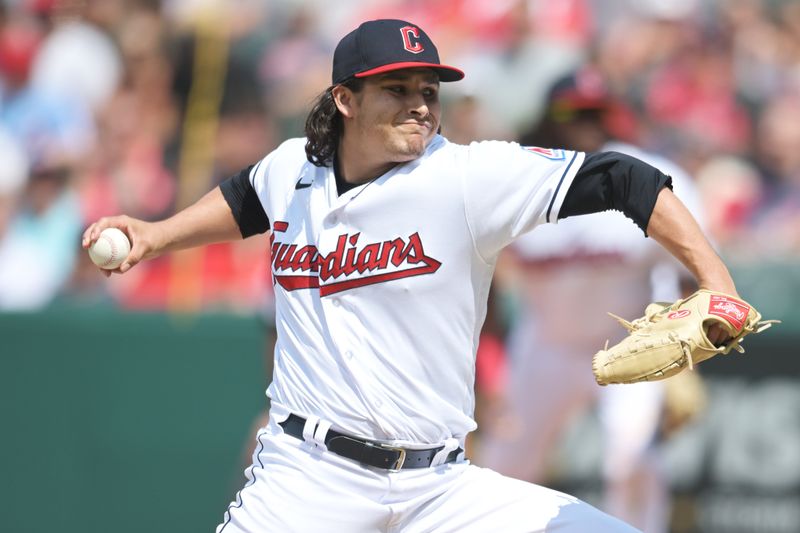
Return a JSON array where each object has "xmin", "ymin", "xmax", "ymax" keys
[{"xmin": 478, "ymin": 68, "xmax": 699, "ymax": 533}]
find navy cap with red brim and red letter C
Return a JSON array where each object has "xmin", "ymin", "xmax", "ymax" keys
[{"xmin": 332, "ymin": 19, "xmax": 464, "ymax": 85}]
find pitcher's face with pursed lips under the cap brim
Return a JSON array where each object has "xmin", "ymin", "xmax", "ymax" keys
[{"xmin": 352, "ymin": 68, "xmax": 442, "ymax": 163}]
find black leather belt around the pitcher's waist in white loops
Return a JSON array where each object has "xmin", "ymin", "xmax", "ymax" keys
[{"xmin": 280, "ymin": 415, "xmax": 464, "ymax": 471}]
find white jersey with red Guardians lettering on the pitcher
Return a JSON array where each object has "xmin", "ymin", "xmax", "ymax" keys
[{"xmin": 250, "ymin": 136, "xmax": 584, "ymax": 444}]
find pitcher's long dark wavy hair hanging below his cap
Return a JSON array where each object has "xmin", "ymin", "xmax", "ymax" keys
[{"xmin": 306, "ymin": 78, "xmax": 364, "ymax": 167}]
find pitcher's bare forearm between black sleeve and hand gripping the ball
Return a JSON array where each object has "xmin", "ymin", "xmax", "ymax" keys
[{"xmin": 154, "ymin": 187, "xmax": 242, "ymax": 254}]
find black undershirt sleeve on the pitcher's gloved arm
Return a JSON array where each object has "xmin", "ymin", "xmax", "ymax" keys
[{"xmin": 558, "ymin": 152, "xmax": 672, "ymax": 235}]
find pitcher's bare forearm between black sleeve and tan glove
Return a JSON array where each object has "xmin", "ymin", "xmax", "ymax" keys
[{"xmin": 647, "ymin": 188, "xmax": 736, "ymax": 295}]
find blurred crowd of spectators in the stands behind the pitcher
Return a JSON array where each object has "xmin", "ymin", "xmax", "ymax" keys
[{"xmin": 0, "ymin": 0, "xmax": 800, "ymax": 310}]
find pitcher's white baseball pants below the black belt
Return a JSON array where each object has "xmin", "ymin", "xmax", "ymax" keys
[{"xmin": 217, "ymin": 416, "xmax": 636, "ymax": 533}]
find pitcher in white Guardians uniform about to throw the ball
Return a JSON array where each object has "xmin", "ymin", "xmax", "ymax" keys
[{"xmin": 83, "ymin": 20, "xmax": 768, "ymax": 533}]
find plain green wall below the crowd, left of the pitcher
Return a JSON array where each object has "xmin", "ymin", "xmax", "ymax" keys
[{"xmin": 0, "ymin": 309, "xmax": 268, "ymax": 533}]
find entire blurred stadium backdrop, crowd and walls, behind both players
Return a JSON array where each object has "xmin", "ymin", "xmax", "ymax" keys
[{"xmin": 0, "ymin": 0, "xmax": 800, "ymax": 533}]
